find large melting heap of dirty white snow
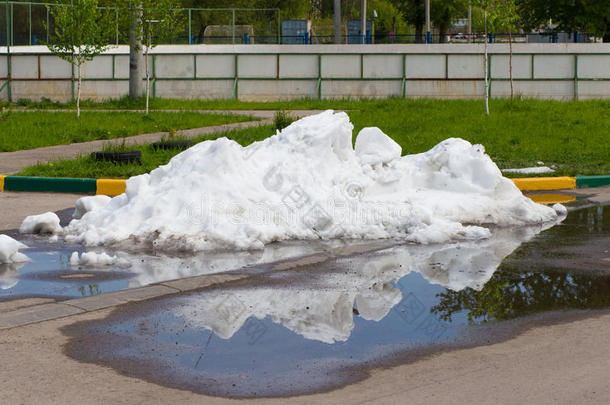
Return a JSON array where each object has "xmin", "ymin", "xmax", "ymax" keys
[{"xmin": 64, "ymin": 110, "xmax": 558, "ymax": 251}]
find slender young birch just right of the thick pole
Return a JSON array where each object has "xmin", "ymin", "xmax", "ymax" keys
[{"xmin": 123, "ymin": 0, "xmax": 184, "ymax": 115}]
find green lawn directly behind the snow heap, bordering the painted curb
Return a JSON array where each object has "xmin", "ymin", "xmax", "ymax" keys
[{"xmin": 13, "ymin": 99, "xmax": 610, "ymax": 177}]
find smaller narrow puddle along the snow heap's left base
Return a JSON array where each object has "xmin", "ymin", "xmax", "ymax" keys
[{"xmin": 0, "ymin": 232, "xmax": 360, "ymax": 300}]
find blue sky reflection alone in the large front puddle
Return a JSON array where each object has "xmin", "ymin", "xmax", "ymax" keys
[{"xmin": 100, "ymin": 272, "xmax": 467, "ymax": 395}]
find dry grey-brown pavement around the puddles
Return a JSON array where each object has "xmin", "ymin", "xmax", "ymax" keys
[{"xmin": 0, "ymin": 187, "xmax": 610, "ymax": 405}]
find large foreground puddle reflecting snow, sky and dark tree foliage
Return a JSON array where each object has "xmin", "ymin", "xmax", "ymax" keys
[{"xmin": 65, "ymin": 207, "xmax": 610, "ymax": 397}]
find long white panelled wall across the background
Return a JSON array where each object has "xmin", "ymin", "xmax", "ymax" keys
[{"xmin": 0, "ymin": 44, "xmax": 610, "ymax": 101}]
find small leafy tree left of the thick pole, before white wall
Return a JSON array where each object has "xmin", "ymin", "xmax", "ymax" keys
[{"xmin": 47, "ymin": 0, "xmax": 115, "ymax": 117}]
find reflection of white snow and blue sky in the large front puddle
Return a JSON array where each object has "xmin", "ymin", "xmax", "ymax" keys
[{"xmin": 95, "ymin": 223, "xmax": 540, "ymax": 395}]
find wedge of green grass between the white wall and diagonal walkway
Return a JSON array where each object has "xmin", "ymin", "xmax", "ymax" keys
[{"xmin": 0, "ymin": 111, "xmax": 254, "ymax": 152}]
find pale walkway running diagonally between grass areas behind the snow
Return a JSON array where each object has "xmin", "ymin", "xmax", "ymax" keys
[{"xmin": 0, "ymin": 110, "xmax": 319, "ymax": 174}]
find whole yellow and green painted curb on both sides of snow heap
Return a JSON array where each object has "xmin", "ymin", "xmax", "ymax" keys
[{"xmin": 0, "ymin": 175, "xmax": 610, "ymax": 196}]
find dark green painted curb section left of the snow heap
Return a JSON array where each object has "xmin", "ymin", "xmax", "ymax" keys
[{"xmin": 4, "ymin": 176, "xmax": 97, "ymax": 194}]
